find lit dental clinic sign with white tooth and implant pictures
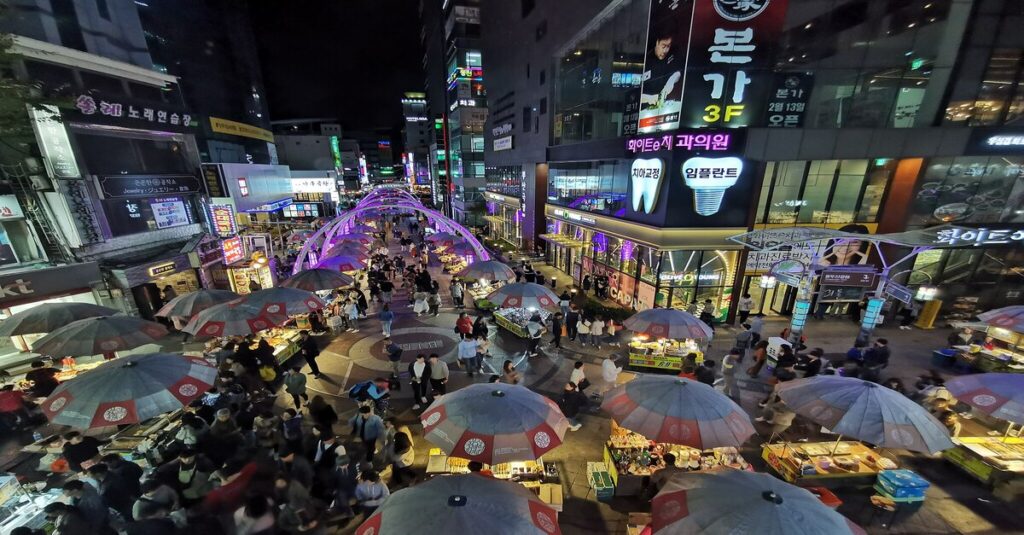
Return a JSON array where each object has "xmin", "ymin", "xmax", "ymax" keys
[{"xmin": 624, "ymin": 129, "xmax": 753, "ymax": 227}]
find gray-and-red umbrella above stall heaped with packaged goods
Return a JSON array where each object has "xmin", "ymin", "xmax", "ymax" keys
[{"xmin": 601, "ymin": 375, "xmax": 756, "ymax": 450}]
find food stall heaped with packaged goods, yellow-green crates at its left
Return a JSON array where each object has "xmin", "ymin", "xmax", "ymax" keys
[{"xmin": 603, "ymin": 420, "xmax": 752, "ymax": 496}]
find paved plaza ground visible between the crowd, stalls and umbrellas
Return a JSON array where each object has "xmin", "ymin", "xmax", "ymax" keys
[{"xmin": 0, "ymin": 243, "xmax": 1024, "ymax": 534}]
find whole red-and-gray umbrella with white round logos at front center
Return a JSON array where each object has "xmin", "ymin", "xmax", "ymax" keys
[{"xmin": 420, "ymin": 383, "xmax": 569, "ymax": 464}]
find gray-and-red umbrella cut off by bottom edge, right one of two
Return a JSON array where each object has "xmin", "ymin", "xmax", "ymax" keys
[{"xmin": 651, "ymin": 467, "xmax": 864, "ymax": 535}]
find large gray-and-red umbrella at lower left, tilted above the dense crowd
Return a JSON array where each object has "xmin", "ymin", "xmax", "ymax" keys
[{"xmin": 42, "ymin": 353, "xmax": 217, "ymax": 429}]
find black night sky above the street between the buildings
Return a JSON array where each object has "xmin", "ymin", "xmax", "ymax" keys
[{"xmin": 251, "ymin": 0, "xmax": 424, "ymax": 130}]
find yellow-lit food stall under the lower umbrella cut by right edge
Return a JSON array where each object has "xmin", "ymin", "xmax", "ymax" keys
[{"xmin": 942, "ymin": 437, "xmax": 1024, "ymax": 499}]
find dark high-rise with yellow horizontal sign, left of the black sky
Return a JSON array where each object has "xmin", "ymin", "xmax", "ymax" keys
[{"xmin": 135, "ymin": 0, "xmax": 278, "ymax": 164}]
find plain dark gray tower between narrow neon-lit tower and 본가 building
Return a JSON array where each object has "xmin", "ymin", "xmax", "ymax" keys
[{"xmin": 480, "ymin": 0, "xmax": 606, "ymax": 251}]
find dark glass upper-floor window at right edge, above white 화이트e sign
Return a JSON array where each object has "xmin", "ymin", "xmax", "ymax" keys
[{"xmin": 909, "ymin": 156, "xmax": 1024, "ymax": 225}]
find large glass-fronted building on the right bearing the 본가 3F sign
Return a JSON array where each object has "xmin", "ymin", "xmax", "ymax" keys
[{"xmin": 528, "ymin": 0, "xmax": 1024, "ymax": 319}]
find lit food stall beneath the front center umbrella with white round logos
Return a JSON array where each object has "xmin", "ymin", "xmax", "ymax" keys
[{"xmin": 427, "ymin": 448, "xmax": 563, "ymax": 512}]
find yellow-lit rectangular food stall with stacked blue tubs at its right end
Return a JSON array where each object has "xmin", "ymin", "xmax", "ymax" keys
[{"xmin": 761, "ymin": 441, "xmax": 897, "ymax": 487}]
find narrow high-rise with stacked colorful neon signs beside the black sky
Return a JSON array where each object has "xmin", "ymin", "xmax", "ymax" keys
[{"xmin": 421, "ymin": 0, "xmax": 487, "ymax": 224}]
